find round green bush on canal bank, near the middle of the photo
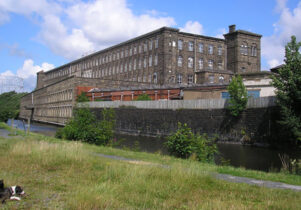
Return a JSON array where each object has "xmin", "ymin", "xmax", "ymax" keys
[{"xmin": 166, "ymin": 123, "xmax": 217, "ymax": 162}]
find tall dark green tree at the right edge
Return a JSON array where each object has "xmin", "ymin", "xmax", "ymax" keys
[{"xmin": 272, "ymin": 36, "xmax": 301, "ymax": 141}]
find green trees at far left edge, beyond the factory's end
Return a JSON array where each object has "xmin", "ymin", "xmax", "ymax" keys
[{"xmin": 0, "ymin": 91, "xmax": 27, "ymax": 122}]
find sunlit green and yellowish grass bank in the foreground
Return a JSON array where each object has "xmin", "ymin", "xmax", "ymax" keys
[{"xmin": 0, "ymin": 123, "xmax": 301, "ymax": 209}]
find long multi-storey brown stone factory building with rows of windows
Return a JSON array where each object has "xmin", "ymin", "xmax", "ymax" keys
[{"xmin": 20, "ymin": 25, "xmax": 261, "ymax": 124}]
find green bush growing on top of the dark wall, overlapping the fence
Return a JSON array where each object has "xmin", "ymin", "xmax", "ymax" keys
[{"xmin": 227, "ymin": 75, "xmax": 248, "ymax": 117}]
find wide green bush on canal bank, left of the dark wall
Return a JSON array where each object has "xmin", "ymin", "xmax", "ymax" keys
[{"xmin": 56, "ymin": 107, "xmax": 115, "ymax": 145}]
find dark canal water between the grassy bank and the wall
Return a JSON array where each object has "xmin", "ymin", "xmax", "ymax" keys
[{"xmin": 8, "ymin": 120, "xmax": 301, "ymax": 171}]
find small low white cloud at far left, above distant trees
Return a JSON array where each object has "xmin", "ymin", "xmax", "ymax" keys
[{"xmin": 0, "ymin": 59, "xmax": 55, "ymax": 92}]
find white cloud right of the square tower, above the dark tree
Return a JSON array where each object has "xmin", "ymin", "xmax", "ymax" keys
[{"xmin": 262, "ymin": 0, "xmax": 301, "ymax": 68}]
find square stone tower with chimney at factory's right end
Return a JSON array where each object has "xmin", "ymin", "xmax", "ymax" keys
[{"xmin": 224, "ymin": 25, "xmax": 261, "ymax": 74}]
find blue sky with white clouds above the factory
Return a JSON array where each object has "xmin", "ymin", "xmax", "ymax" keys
[{"xmin": 0, "ymin": 0, "xmax": 301, "ymax": 91}]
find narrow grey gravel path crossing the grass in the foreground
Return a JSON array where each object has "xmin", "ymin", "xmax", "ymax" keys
[{"xmin": 94, "ymin": 153, "xmax": 301, "ymax": 192}]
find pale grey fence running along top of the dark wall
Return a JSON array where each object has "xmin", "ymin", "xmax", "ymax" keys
[{"xmin": 78, "ymin": 97, "xmax": 276, "ymax": 109}]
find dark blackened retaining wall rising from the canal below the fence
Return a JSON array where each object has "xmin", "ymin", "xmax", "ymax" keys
[{"xmin": 91, "ymin": 107, "xmax": 279, "ymax": 142}]
